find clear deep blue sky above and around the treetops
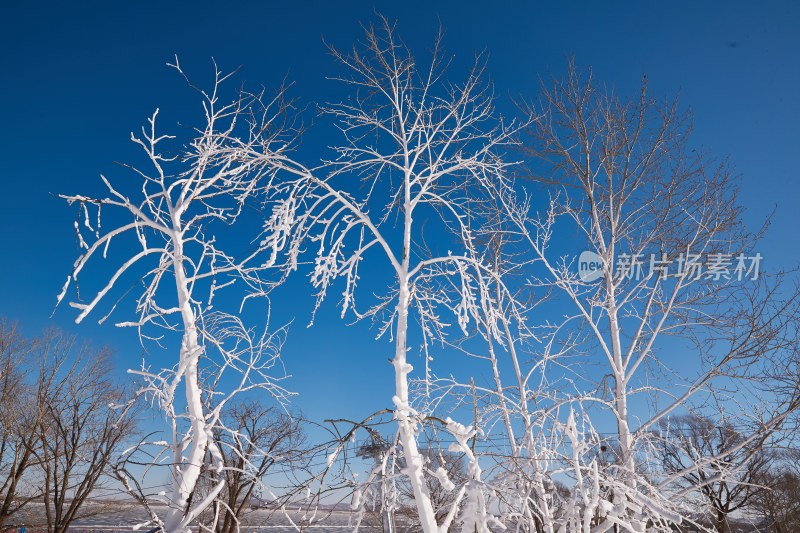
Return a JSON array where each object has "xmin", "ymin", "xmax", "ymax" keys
[{"xmin": 0, "ymin": 1, "xmax": 800, "ymax": 419}]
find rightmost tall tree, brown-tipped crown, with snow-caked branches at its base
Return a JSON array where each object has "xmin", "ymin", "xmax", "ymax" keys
[{"xmin": 418, "ymin": 60, "xmax": 798, "ymax": 533}]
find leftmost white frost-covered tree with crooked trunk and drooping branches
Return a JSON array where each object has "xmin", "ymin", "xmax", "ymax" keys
[{"xmin": 58, "ymin": 59, "xmax": 300, "ymax": 533}]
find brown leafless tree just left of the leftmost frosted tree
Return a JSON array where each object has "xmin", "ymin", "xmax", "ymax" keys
[{"xmin": 37, "ymin": 332, "xmax": 136, "ymax": 533}]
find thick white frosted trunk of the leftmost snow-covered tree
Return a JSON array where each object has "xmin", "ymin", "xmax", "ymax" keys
[{"xmin": 164, "ymin": 239, "xmax": 208, "ymax": 533}]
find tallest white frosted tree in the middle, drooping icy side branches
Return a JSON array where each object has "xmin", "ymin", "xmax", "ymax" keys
[{"xmin": 276, "ymin": 19, "xmax": 514, "ymax": 533}]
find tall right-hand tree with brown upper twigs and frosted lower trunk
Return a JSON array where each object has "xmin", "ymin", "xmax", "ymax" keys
[{"xmin": 472, "ymin": 64, "xmax": 798, "ymax": 532}]
